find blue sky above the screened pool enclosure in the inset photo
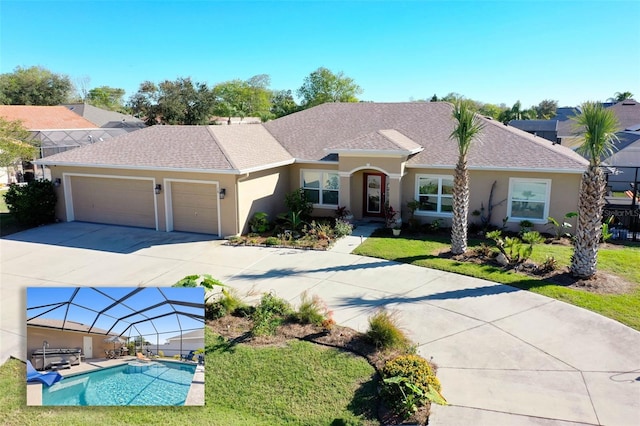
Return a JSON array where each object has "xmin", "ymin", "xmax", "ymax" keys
[{"xmin": 26, "ymin": 287, "xmax": 204, "ymax": 343}]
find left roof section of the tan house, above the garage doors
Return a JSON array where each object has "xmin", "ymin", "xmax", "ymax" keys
[{"xmin": 38, "ymin": 125, "xmax": 294, "ymax": 173}]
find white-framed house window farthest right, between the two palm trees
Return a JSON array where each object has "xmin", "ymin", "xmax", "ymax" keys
[{"xmin": 507, "ymin": 178, "xmax": 551, "ymax": 223}]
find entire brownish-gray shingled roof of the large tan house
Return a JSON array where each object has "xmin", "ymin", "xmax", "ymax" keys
[{"xmin": 38, "ymin": 102, "xmax": 587, "ymax": 173}]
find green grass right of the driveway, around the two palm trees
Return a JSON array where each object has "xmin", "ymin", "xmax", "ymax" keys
[{"xmin": 354, "ymin": 235, "xmax": 640, "ymax": 330}]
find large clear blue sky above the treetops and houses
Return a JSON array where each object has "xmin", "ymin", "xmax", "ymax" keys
[{"xmin": 0, "ymin": 0, "xmax": 640, "ymax": 107}]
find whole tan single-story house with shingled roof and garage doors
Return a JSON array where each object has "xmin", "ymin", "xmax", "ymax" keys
[{"xmin": 38, "ymin": 102, "xmax": 587, "ymax": 237}]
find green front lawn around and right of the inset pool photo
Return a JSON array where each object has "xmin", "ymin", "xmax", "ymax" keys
[{"xmin": 0, "ymin": 329, "xmax": 378, "ymax": 426}]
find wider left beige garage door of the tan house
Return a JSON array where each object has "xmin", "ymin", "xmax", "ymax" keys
[{"xmin": 71, "ymin": 176, "xmax": 156, "ymax": 229}]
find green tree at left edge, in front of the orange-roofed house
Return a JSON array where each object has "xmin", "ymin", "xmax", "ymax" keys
[{"xmin": 0, "ymin": 117, "xmax": 39, "ymax": 167}]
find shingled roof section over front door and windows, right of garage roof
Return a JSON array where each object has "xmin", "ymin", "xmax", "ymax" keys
[{"xmin": 265, "ymin": 102, "xmax": 587, "ymax": 171}]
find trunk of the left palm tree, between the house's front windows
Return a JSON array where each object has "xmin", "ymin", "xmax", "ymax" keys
[{"xmin": 451, "ymin": 157, "xmax": 469, "ymax": 254}]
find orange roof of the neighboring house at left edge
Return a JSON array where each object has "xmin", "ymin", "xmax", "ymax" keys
[{"xmin": 0, "ymin": 105, "xmax": 98, "ymax": 130}]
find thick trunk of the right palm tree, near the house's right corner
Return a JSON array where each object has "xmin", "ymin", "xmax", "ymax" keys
[{"xmin": 571, "ymin": 165, "xmax": 606, "ymax": 278}]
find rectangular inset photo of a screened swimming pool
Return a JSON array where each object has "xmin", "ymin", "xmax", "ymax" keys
[{"xmin": 26, "ymin": 287, "xmax": 205, "ymax": 406}]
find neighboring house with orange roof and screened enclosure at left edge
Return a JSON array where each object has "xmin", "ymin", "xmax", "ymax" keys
[{"xmin": 0, "ymin": 105, "xmax": 128, "ymax": 183}]
